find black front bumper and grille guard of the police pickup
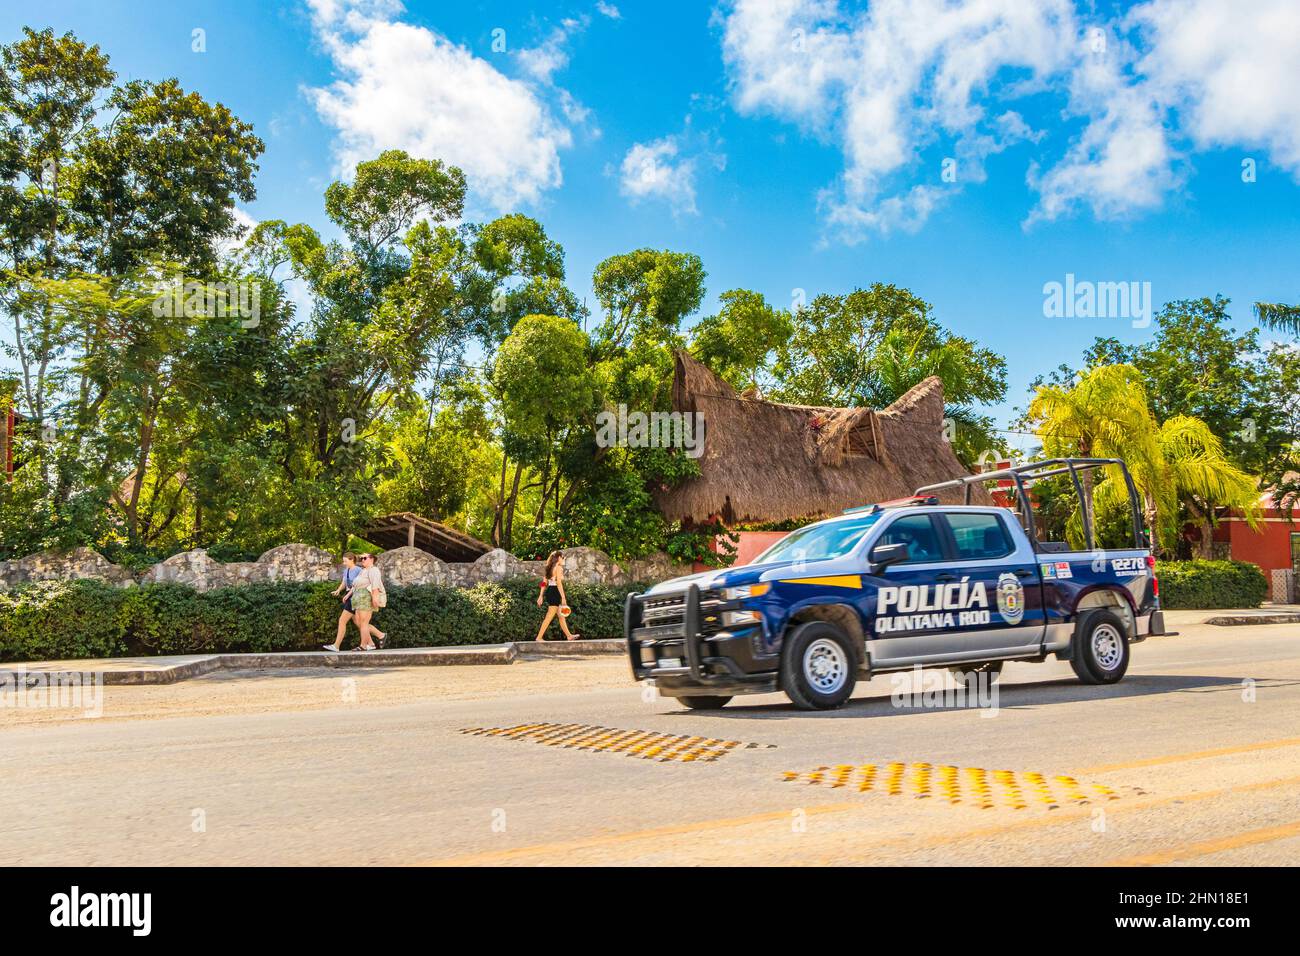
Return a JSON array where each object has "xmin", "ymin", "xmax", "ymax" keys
[{"xmin": 623, "ymin": 584, "xmax": 777, "ymax": 697}]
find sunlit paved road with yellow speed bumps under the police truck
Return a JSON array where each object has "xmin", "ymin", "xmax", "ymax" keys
[{"xmin": 0, "ymin": 613, "xmax": 1300, "ymax": 865}]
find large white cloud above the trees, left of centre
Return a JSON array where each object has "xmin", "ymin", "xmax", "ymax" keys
[{"xmin": 308, "ymin": 0, "xmax": 572, "ymax": 209}]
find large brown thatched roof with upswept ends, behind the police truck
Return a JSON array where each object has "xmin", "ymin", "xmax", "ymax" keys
[{"xmin": 655, "ymin": 351, "xmax": 991, "ymax": 525}]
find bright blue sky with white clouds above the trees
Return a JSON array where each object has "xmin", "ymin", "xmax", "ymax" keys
[{"xmin": 0, "ymin": 0, "xmax": 1300, "ymax": 442}]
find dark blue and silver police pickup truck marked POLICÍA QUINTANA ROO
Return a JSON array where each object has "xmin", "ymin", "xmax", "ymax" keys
[{"xmin": 624, "ymin": 458, "xmax": 1164, "ymax": 710}]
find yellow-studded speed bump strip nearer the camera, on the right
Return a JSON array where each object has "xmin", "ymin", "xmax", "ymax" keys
[{"xmin": 785, "ymin": 761, "xmax": 1141, "ymax": 810}]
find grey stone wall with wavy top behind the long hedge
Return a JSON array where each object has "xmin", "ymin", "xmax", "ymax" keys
[{"xmin": 0, "ymin": 544, "xmax": 690, "ymax": 591}]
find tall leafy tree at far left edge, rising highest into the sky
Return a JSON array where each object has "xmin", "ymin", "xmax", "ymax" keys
[{"xmin": 0, "ymin": 30, "xmax": 263, "ymax": 556}]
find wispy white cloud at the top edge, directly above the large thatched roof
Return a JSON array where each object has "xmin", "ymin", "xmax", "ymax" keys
[{"xmin": 723, "ymin": 0, "xmax": 1076, "ymax": 241}]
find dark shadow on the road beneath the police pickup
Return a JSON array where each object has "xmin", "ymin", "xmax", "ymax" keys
[{"xmin": 667, "ymin": 674, "xmax": 1300, "ymax": 721}]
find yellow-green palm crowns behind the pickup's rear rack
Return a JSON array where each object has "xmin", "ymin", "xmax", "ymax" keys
[{"xmin": 1028, "ymin": 364, "xmax": 1260, "ymax": 557}]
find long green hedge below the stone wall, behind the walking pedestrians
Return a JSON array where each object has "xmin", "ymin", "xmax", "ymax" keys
[{"xmin": 0, "ymin": 579, "xmax": 642, "ymax": 661}]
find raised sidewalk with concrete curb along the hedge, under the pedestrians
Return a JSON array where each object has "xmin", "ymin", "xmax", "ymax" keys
[{"xmin": 0, "ymin": 639, "xmax": 625, "ymax": 684}]
